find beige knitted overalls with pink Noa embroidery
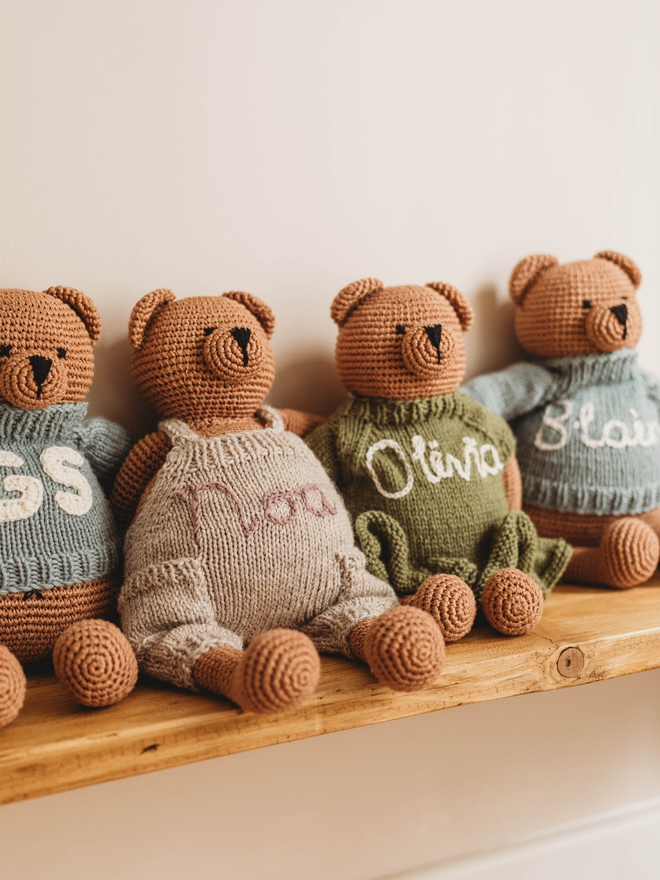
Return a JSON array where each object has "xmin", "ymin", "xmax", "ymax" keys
[{"xmin": 119, "ymin": 407, "xmax": 398, "ymax": 689}]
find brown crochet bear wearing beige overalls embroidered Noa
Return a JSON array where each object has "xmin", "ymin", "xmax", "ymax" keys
[{"xmin": 114, "ymin": 290, "xmax": 444, "ymax": 713}]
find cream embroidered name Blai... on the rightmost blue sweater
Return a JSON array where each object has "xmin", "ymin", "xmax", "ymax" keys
[{"xmin": 534, "ymin": 400, "xmax": 660, "ymax": 452}]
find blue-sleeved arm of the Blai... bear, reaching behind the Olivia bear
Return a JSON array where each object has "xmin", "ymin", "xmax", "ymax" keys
[{"xmin": 460, "ymin": 363, "xmax": 558, "ymax": 422}]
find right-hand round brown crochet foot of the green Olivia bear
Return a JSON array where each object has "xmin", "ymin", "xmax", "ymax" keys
[{"xmin": 481, "ymin": 568, "xmax": 543, "ymax": 636}]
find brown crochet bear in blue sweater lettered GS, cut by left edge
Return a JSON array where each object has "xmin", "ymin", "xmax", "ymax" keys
[{"xmin": 0, "ymin": 287, "xmax": 137, "ymax": 727}]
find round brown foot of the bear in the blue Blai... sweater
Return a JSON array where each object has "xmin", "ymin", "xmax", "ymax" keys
[{"xmin": 600, "ymin": 517, "xmax": 660, "ymax": 588}]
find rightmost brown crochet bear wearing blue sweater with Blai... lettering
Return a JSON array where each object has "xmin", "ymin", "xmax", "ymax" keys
[{"xmin": 464, "ymin": 251, "xmax": 660, "ymax": 587}]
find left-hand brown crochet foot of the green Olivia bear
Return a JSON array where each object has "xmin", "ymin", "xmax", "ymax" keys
[{"xmin": 401, "ymin": 574, "xmax": 477, "ymax": 642}]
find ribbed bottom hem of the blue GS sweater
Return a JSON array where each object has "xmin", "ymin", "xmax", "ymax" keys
[{"xmin": 0, "ymin": 545, "xmax": 119, "ymax": 595}]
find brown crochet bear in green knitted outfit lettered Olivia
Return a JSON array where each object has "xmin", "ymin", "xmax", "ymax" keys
[{"xmin": 307, "ymin": 278, "xmax": 570, "ymax": 641}]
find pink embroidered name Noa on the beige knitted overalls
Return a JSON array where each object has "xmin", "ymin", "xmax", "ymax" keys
[{"xmin": 179, "ymin": 483, "xmax": 337, "ymax": 546}]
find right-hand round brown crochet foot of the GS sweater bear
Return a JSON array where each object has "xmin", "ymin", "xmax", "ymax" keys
[{"xmin": 53, "ymin": 620, "xmax": 138, "ymax": 708}]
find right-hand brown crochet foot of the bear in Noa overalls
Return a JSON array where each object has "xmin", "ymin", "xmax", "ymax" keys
[{"xmin": 350, "ymin": 606, "xmax": 445, "ymax": 692}]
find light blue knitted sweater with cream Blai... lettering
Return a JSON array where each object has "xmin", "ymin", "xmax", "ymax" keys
[{"xmin": 464, "ymin": 349, "xmax": 660, "ymax": 516}]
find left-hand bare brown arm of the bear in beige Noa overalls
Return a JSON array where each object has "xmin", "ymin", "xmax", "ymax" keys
[{"xmin": 110, "ymin": 431, "xmax": 172, "ymax": 532}]
